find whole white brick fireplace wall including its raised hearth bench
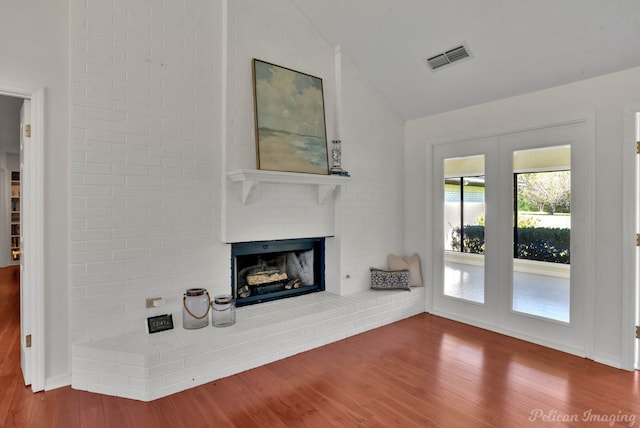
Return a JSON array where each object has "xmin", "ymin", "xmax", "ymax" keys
[{"xmin": 70, "ymin": 0, "xmax": 424, "ymax": 400}]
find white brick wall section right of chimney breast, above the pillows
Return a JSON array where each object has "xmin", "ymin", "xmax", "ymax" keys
[{"xmin": 337, "ymin": 55, "xmax": 404, "ymax": 294}]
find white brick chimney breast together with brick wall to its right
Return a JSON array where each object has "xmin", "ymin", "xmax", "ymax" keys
[{"xmin": 222, "ymin": 0, "xmax": 404, "ymax": 295}]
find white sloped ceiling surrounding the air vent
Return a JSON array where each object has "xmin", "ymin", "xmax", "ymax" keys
[{"xmin": 292, "ymin": 0, "xmax": 640, "ymax": 119}]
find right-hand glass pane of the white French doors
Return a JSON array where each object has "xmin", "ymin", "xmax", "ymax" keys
[{"xmin": 512, "ymin": 146, "xmax": 571, "ymax": 322}]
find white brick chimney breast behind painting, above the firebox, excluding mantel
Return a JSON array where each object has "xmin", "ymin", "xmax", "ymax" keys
[{"xmin": 222, "ymin": 0, "xmax": 335, "ymax": 242}]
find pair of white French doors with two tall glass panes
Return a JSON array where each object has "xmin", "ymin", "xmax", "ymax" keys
[{"xmin": 432, "ymin": 121, "xmax": 593, "ymax": 355}]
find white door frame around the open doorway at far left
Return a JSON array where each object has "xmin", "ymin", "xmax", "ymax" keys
[{"xmin": 0, "ymin": 84, "xmax": 45, "ymax": 392}]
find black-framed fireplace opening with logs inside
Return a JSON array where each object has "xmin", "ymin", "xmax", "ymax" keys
[{"xmin": 231, "ymin": 238, "xmax": 325, "ymax": 306}]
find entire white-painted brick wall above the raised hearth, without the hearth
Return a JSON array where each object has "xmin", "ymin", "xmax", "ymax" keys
[{"xmin": 70, "ymin": 0, "xmax": 403, "ymax": 352}]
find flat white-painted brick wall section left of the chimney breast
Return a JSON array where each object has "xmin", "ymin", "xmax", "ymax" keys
[{"xmin": 70, "ymin": 0, "xmax": 222, "ymax": 343}]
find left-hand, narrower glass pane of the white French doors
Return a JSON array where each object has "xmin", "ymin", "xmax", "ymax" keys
[{"xmin": 444, "ymin": 155, "xmax": 485, "ymax": 303}]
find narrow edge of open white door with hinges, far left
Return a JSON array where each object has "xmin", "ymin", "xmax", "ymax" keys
[{"xmin": 20, "ymin": 100, "xmax": 31, "ymax": 385}]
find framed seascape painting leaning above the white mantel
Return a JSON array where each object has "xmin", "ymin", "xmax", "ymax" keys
[{"xmin": 253, "ymin": 59, "xmax": 329, "ymax": 174}]
